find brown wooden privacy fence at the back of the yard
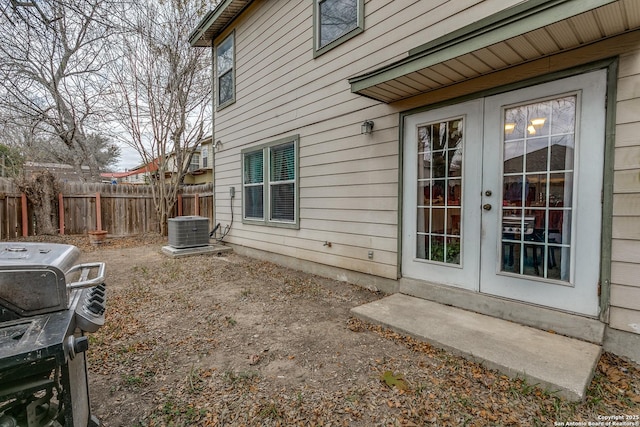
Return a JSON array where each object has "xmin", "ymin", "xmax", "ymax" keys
[{"xmin": 0, "ymin": 178, "xmax": 213, "ymax": 240}]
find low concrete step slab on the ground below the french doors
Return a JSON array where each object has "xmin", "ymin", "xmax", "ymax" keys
[{"xmin": 351, "ymin": 294, "xmax": 602, "ymax": 401}]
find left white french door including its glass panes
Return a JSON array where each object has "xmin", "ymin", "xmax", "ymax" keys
[{"xmin": 402, "ymin": 100, "xmax": 483, "ymax": 291}]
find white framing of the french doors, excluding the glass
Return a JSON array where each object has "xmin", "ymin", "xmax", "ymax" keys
[{"xmin": 401, "ymin": 70, "xmax": 607, "ymax": 316}]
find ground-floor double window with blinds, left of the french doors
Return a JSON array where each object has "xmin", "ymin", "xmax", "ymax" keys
[{"xmin": 242, "ymin": 135, "xmax": 298, "ymax": 228}]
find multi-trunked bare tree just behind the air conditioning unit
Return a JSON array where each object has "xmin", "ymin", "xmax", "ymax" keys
[{"xmin": 111, "ymin": 0, "xmax": 211, "ymax": 234}]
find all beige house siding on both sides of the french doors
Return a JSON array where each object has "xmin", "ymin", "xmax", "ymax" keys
[{"xmin": 206, "ymin": 0, "xmax": 640, "ymax": 358}]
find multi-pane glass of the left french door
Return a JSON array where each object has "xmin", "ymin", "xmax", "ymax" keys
[{"xmin": 416, "ymin": 118, "xmax": 463, "ymax": 265}]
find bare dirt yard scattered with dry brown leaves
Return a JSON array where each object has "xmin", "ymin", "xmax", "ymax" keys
[{"xmin": 20, "ymin": 236, "xmax": 640, "ymax": 427}]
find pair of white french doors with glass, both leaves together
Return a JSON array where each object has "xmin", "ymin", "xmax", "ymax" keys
[{"xmin": 402, "ymin": 70, "xmax": 606, "ymax": 316}]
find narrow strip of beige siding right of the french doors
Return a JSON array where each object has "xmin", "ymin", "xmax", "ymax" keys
[{"xmin": 609, "ymin": 46, "xmax": 640, "ymax": 340}]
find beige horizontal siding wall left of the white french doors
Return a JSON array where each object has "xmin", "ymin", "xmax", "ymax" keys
[{"xmin": 214, "ymin": 0, "xmax": 517, "ymax": 278}]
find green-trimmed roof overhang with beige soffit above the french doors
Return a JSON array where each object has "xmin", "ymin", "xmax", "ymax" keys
[{"xmin": 349, "ymin": 0, "xmax": 640, "ymax": 103}]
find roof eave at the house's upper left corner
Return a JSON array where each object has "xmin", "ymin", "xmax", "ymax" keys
[{"xmin": 189, "ymin": 0, "xmax": 253, "ymax": 47}]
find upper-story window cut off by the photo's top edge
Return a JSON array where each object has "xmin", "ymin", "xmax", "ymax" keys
[{"xmin": 313, "ymin": 0, "xmax": 364, "ymax": 56}]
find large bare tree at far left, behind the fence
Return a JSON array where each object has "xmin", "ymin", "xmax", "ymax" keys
[{"xmin": 0, "ymin": 0, "xmax": 112, "ymax": 181}]
